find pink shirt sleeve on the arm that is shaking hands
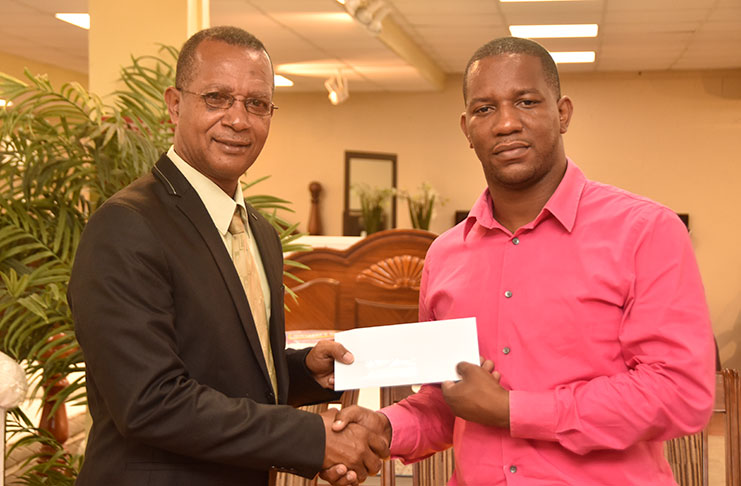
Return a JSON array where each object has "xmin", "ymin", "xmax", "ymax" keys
[{"xmin": 381, "ymin": 253, "xmax": 455, "ymax": 464}]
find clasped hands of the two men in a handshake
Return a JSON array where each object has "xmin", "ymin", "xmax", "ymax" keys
[{"xmin": 319, "ymin": 405, "xmax": 391, "ymax": 486}]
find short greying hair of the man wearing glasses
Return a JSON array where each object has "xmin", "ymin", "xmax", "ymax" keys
[{"xmin": 175, "ymin": 25, "xmax": 273, "ymax": 89}]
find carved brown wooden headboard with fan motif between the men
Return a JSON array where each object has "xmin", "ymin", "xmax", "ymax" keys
[{"xmin": 284, "ymin": 229, "xmax": 436, "ymax": 330}]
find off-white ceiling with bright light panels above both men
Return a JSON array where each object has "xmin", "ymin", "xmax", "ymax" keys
[{"xmin": 0, "ymin": 0, "xmax": 741, "ymax": 91}]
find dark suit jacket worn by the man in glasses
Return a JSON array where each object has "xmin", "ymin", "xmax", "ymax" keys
[{"xmin": 68, "ymin": 156, "xmax": 335, "ymax": 486}]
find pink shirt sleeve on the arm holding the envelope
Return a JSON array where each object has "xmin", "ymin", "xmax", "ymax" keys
[{"xmin": 510, "ymin": 210, "xmax": 715, "ymax": 454}]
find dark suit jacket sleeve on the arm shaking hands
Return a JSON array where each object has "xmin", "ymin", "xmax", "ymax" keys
[{"xmin": 68, "ymin": 201, "xmax": 325, "ymax": 477}]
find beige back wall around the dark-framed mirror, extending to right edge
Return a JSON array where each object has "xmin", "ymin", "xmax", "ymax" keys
[{"xmin": 248, "ymin": 71, "xmax": 741, "ymax": 368}]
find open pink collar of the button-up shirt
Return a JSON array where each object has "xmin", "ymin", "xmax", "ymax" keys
[{"xmin": 464, "ymin": 158, "xmax": 586, "ymax": 235}]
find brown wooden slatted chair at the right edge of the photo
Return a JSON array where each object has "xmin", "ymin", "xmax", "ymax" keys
[{"xmin": 665, "ymin": 368, "xmax": 741, "ymax": 486}]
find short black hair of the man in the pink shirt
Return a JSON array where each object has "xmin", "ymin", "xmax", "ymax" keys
[{"xmin": 463, "ymin": 37, "xmax": 561, "ymax": 102}]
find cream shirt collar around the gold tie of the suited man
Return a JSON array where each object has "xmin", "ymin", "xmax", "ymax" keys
[{"xmin": 167, "ymin": 146, "xmax": 247, "ymax": 236}]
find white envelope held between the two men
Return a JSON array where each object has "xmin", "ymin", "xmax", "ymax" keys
[{"xmin": 334, "ymin": 317, "xmax": 479, "ymax": 390}]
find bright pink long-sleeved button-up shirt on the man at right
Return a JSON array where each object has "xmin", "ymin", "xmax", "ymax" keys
[{"xmin": 383, "ymin": 161, "xmax": 715, "ymax": 486}]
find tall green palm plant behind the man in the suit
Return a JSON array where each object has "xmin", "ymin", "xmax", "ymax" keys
[{"xmin": 0, "ymin": 46, "xmax": 304, "ymax": 485}]
